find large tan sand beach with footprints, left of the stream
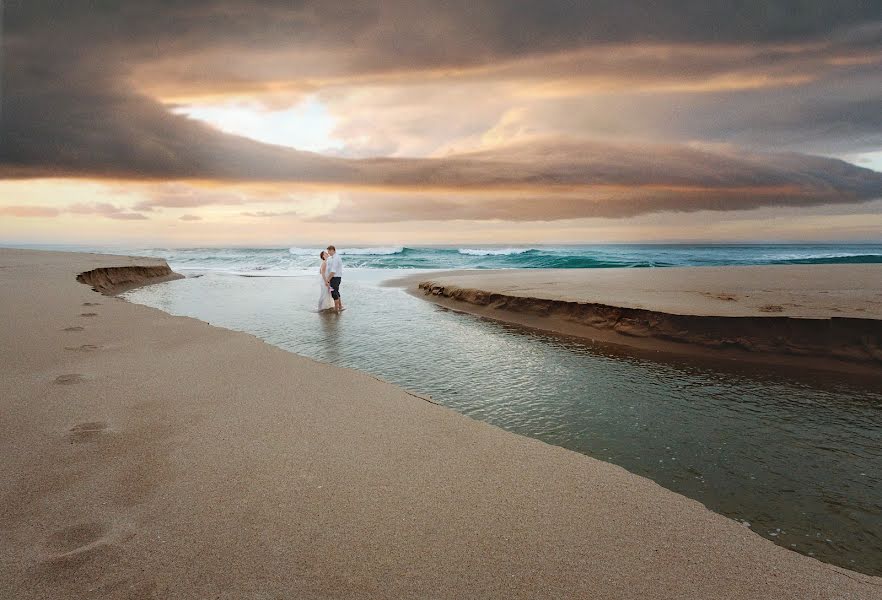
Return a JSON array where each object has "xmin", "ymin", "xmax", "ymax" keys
[{"xmin": 0, "ymin": 250, "xmax": 882, "ymax": 599}]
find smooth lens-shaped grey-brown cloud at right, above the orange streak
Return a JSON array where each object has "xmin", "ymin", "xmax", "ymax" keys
[{"xmin": 362, "ymin": 138, "xmax": 882, "ymax": 199}]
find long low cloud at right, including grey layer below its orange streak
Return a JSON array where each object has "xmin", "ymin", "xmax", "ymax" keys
[{"xmin": 317, "ymin": 140, "xmax": 882, "ymax": 222}]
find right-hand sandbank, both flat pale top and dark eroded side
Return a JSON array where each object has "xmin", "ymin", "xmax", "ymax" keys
[{"xmin": 402, "ymin": 265, "xmax": 882, "ymax": 372}]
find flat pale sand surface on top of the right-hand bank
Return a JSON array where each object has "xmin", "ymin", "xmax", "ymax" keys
[{"xmin": 410, "ymin": 265, "xmax": 882, "ymax": 319}]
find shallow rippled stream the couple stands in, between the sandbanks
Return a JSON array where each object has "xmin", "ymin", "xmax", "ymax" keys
[{"xmin": 126, "ymin": 268, "xmax": 882, "ymax": 575}]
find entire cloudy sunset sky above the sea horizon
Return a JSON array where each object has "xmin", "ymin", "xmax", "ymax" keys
[{"xmin": 0, "ymin": 0, "xmax": 882, "ymax": 246}]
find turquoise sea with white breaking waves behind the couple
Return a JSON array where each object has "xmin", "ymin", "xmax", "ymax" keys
[{"xmin": 125, "ymin": 244, "xmax": 882, "ymax": 276}]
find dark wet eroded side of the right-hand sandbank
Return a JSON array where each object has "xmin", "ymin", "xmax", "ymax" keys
[{"xmin": 384, "ymin": 272, "xmax": 882, "ymax": 379}]
